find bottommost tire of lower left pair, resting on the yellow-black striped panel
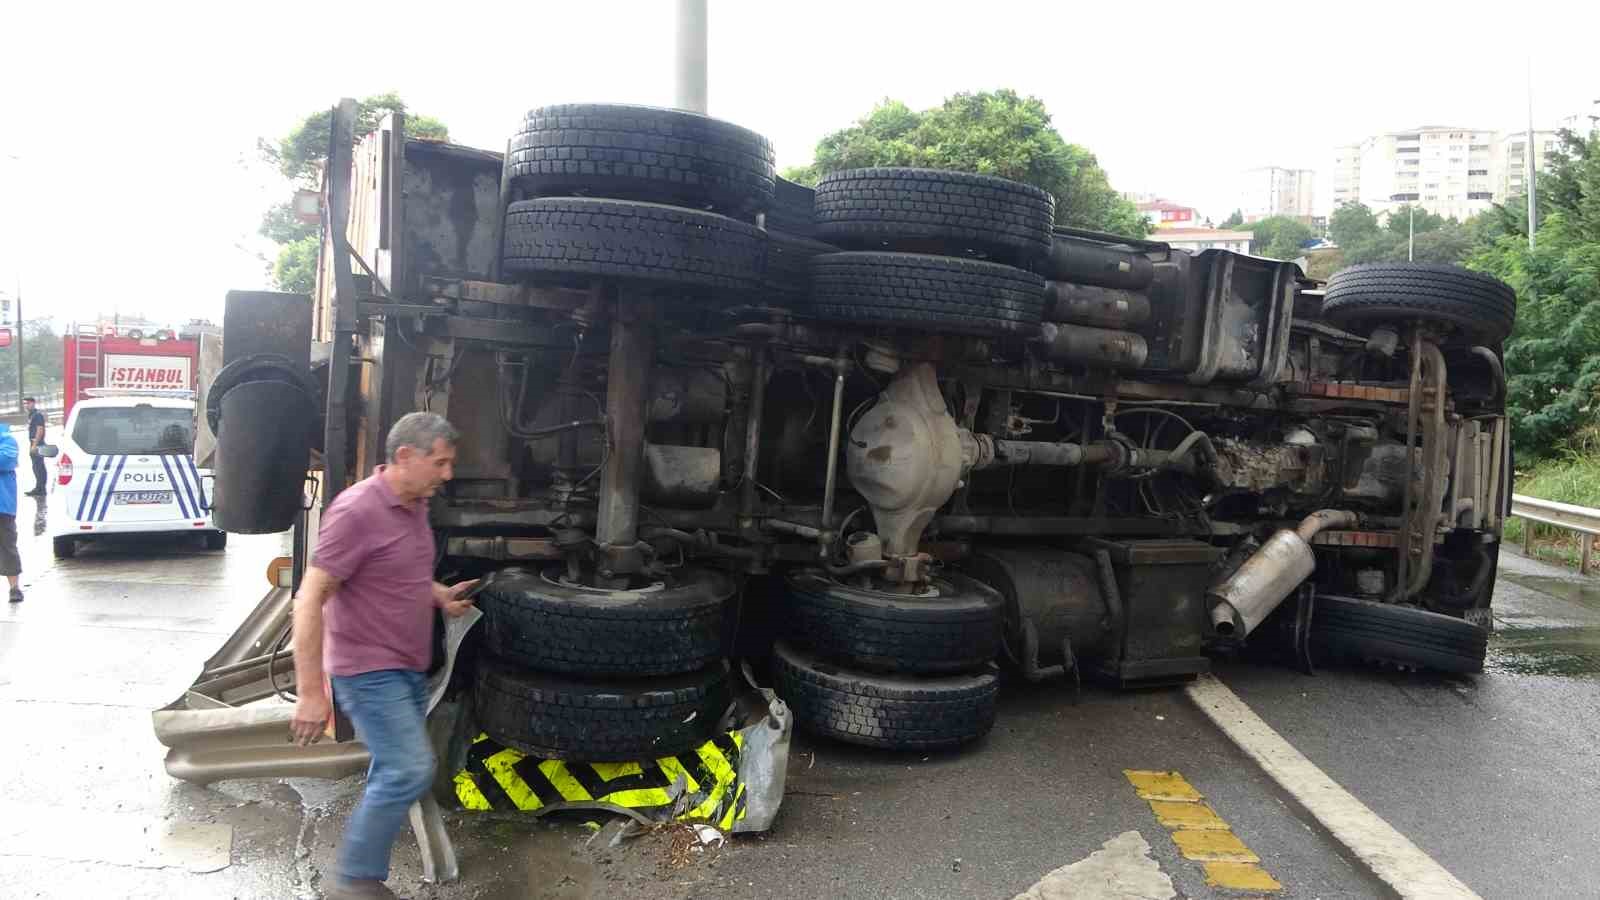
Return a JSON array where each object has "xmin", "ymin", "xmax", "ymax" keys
[{"xmin": 472, "ymin": 657, "xmax": 733, "ymax": 762}]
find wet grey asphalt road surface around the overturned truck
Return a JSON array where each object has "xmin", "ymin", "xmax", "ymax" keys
[{"xmin": 0, "ymin": 498, "xmax": 1600, "ymax": 900}]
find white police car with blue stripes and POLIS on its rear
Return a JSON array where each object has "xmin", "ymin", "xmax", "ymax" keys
[{"xmin": 46, "ymin": 389, "xmax": 227, "ymax": 559}]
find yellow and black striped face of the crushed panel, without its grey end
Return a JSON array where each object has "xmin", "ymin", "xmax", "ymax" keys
[{"xmin": 456, "ymin": 732, "xmax": 746, "ymax": 831}]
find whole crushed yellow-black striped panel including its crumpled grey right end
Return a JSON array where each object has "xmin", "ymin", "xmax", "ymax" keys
[{"xmin": 454, "ymin": 666, "xmax": 794, "ymax": 833}]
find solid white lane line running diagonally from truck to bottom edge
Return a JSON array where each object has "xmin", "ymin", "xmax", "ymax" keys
[{"xmin": 1187, "ymin": 674, "xmax": 1482, "ymax": 900}]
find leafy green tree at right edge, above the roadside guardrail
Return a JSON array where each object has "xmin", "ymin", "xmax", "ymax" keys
[{"xmin": 1467, "ymin": 135, "xmax": 1600, "ymax": 458}]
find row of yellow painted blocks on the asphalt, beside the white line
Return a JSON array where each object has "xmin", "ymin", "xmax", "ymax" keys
[{"xmin": 1122, "ymin": 769, "xmax": 1283, "ymax": 894}]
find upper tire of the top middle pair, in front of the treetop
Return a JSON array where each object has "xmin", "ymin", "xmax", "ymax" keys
[{"xmin": 813, "ymin": 168, "xmax": 1056, "ymax": 266}]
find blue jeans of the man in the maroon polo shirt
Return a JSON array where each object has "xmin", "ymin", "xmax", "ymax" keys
[{"xmin": 333, "ymin": 669, "xmax": 434, "ymax": 881}]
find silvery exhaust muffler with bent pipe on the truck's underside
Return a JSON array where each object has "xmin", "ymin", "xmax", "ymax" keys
[{"xmin": 1206, "ymin": 509, "xmax": 1360, "ymax": 637}]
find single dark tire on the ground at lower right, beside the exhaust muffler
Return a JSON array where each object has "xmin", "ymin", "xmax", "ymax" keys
[{"xmin": 1310, "ymin": 597, "xmax": 1488, "ymax": 674}]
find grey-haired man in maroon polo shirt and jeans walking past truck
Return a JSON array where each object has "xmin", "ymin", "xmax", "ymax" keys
[{"xmin": 290, "ymin": 413, "xmax": 474, "ymax": 900}]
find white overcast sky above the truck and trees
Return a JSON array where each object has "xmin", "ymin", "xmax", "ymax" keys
[{"xmin": 0, "ymin": 0, "xmax": 1600, "ymax": 322}]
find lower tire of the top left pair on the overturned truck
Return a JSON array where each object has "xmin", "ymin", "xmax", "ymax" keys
[{"xmin": 504, "ymin": 197, "xmax": 766, "ymax": 291}]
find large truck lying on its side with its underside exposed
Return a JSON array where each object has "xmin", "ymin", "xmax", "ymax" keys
[{"xmin": 206, "ymin": 104, "xmax": 1514, "ymax": 759}]
